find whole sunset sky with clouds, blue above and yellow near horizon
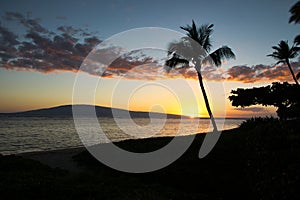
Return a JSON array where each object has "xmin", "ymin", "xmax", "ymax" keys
[{"xmin": 0, "ymin": 0, "xmax": 300, "ymax": 117}]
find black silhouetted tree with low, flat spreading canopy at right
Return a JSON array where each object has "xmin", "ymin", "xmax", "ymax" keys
[{"xmin": 229, "ymin": 82, "xmax": 300, "ymax": 119}]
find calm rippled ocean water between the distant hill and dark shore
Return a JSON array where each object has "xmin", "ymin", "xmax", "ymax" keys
[{"xmin": 0, "ymin": 117, "xmax": 244, "ymax": 155}]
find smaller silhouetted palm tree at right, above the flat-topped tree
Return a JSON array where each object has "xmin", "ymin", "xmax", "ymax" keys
[{"xmin": 267, "ymin": 40, "xmax": 300, "ymax": 85}]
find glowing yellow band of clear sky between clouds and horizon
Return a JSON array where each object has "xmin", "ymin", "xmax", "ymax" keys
[{"xmin": 0, "ymin": 71, "xmax": 275, "ymax": 118}]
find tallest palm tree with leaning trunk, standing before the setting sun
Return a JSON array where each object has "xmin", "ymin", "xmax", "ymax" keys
[{"xmin": 165, "ymin": 20, "xmax": 235, "ymax": 132}]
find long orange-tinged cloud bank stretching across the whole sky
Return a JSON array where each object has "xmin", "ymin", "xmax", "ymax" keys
[{"xmin": 0, "ymin": 12, "xmax": 300, "ymax": 83}]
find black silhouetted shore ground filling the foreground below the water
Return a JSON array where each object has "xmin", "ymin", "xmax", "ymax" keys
[{"xmin": 0, "ymin": 118, "xmax": 300, "ymax": 199}]
